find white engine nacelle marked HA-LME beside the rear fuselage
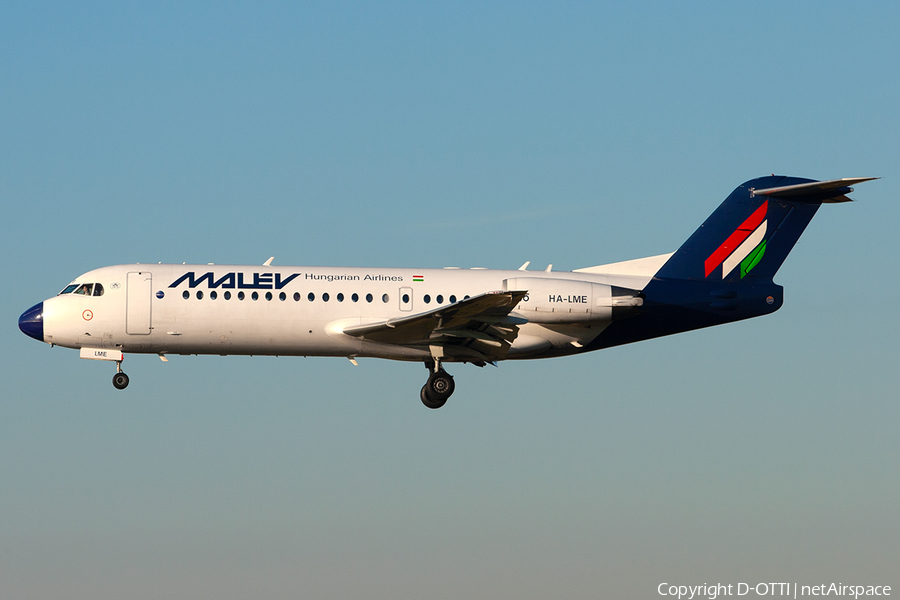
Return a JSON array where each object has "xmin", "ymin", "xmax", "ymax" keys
[{"xmin": 505, "ymin": 277, "xmax": 643, "ymax": 325}]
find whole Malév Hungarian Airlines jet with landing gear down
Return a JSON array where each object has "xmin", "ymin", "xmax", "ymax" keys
[{"xmin": 19, "ymin": 175, "xmax": 877, "ymax": 408}]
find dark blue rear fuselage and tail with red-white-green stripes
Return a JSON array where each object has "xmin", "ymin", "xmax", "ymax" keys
[{"xmin": 592, "ymin": 175, "xmax": 877, "ymax": 348}]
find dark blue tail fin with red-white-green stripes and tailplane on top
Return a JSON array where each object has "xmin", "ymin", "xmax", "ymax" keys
[{"xmin": 656, "ymin": 175, "xmax": 876, "ymax": 282}]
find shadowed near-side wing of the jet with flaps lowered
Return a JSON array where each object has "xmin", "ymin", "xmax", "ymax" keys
[{"xmin": 344, "ymin": 291, "xmax": 528, "ymax": 364}]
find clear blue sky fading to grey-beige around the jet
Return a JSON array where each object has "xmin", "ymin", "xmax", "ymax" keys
[{"xmin": 0, "ymin": 1, "xmax": 900, "ymax": 600}]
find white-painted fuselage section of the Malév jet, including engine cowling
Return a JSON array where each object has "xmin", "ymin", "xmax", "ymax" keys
[{"xmin": 43, "ymin": 256, "xmax": 666, "ymax": 360}]
